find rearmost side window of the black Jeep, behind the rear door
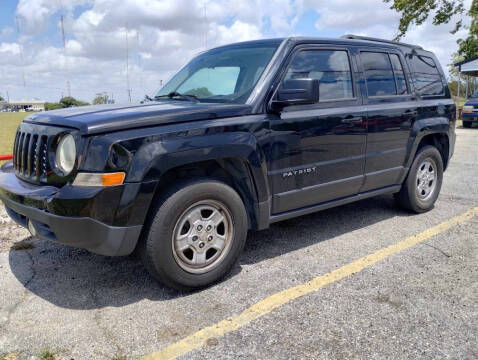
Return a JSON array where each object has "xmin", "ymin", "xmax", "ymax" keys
[{"xmin": 409, "ymin": 55, "xmax": 444, "ymax": 96}]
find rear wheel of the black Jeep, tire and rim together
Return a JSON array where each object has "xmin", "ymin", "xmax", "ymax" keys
[{"xmin": 394, "ymin": 145, "xmax": 443, "ymax": 213}]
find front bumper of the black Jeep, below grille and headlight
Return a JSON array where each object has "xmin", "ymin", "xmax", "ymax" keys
[{"xmin": 0, "ymin": 164, "xmax": 142, "ymax": 256}]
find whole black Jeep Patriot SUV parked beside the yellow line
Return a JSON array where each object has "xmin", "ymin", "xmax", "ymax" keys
[{"xmin": 0, "ymin": 35, "xmax": 456, "ymax": 289}]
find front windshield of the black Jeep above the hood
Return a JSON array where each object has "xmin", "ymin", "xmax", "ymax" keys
[{"xmin": 156, "ymin": 44, "xmax": 278, "ymax": 104}]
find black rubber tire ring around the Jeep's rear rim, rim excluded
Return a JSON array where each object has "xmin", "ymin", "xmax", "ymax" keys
[{"xmin": 407, "ymin": 146, "xmax": 443, "ymax": 212}]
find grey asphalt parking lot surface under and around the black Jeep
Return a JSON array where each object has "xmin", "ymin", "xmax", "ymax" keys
[{"xmin": 0, "ymin": 128, "xmax": 478, "ymax": 360}]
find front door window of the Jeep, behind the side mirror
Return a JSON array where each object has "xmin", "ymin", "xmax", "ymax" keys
[{"xmin": 284, "ymin": 50, "xmax": 354, "ymax": 101}]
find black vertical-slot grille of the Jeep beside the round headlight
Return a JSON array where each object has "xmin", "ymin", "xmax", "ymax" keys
[{"xmin": 13, "ymin": 131, "xmax": 49, "ymax": 182}]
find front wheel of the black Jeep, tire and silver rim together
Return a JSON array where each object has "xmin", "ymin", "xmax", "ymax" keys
[{"xmin": 139, "ymin": 180, "xmax": 248, "ymax": 290}]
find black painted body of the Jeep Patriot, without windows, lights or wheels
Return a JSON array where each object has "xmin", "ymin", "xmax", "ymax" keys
[{"xmin": 0, "ymin": 38, "xmax": 455, "ymax": 255}]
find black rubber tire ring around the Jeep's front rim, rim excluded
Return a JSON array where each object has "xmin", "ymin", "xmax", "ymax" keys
[{"xmin": 144, "ymin": 180, "xmax": 247, "ymax": 290}]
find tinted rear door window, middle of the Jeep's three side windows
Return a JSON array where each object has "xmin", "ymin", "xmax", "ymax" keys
[{"xmin": 360, "ymin": 52, "xmax": 397, "ymax": 96}]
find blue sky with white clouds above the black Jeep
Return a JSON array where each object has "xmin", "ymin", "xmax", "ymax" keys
[{"xmin": 0, "ymin": 0, "xmax": 471, "ymax": 102}]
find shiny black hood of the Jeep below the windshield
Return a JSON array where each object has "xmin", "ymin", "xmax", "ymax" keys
[{"xmin": 23, "ymin": 100, "xmax": 251, "ymax": 134}]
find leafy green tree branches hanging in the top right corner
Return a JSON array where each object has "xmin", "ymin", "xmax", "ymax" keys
[{"xmin": 383, "ymin": 0, "xmax": 478, "ymax": 59}]
